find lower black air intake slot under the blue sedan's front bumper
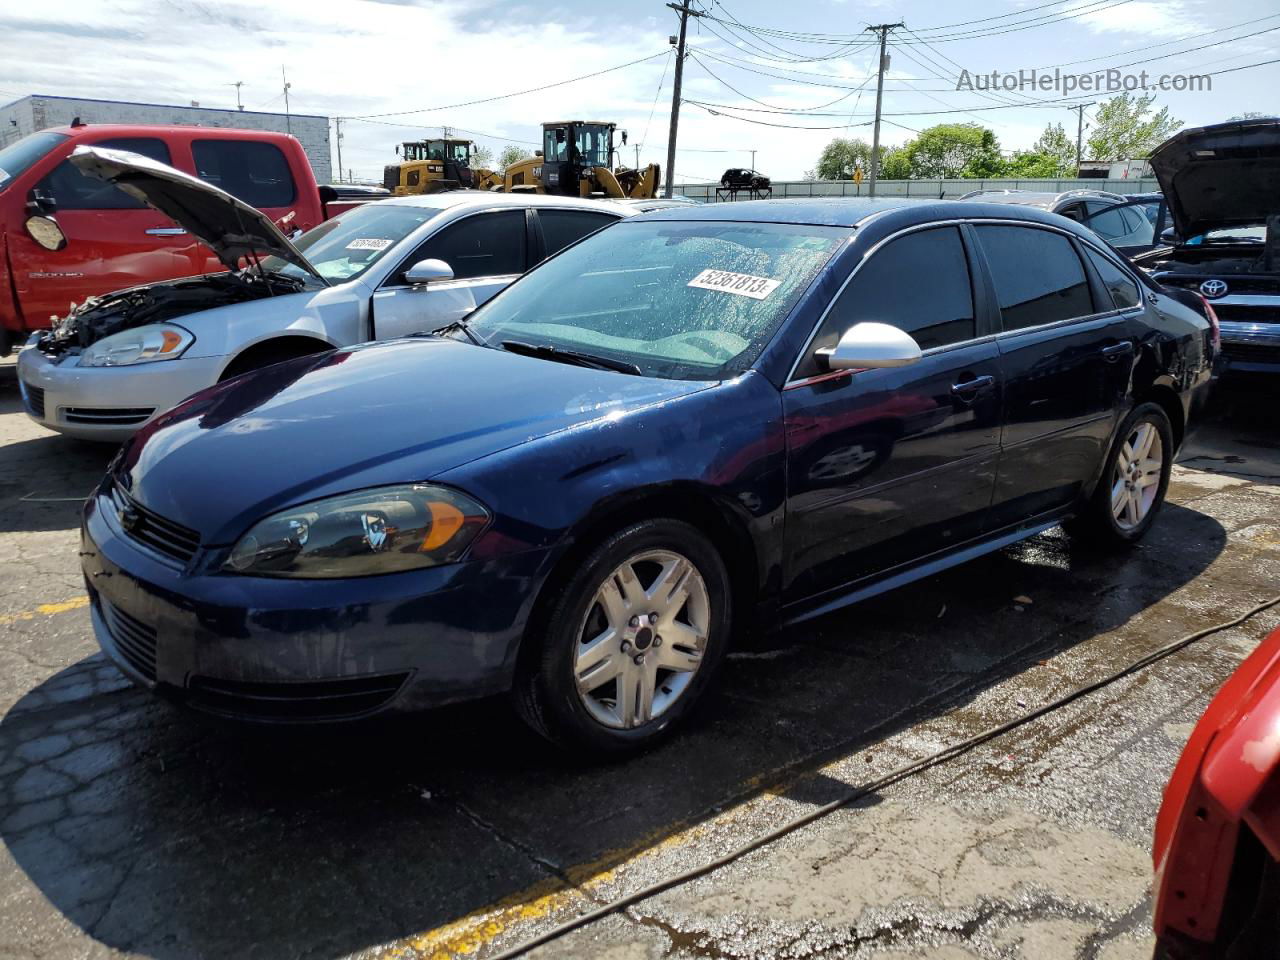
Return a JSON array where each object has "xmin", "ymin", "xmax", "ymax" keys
[{"xmin": 187, "ymin": 673, "xmax": 408, "ymax": 721}]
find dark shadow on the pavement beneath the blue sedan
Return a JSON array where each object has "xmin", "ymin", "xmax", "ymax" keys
[{"xmin": 0, "ymin": 506, "xmax": 1226, "ymax": 959}]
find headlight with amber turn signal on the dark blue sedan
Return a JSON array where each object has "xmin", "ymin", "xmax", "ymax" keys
[{"xmin": 223, "ymin": 484, "xmax": 489, "ymax": 577}]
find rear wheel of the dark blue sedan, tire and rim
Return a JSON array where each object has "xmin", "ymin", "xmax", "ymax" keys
[{"xmin": 1066, "ymin": 403, "xmax": 1174, "ymax": 547}]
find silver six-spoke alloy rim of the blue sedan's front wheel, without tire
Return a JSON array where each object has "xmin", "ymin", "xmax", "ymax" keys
[{"xmin": 573, "ymin": 550, "xmax": 712, "ymax": 730}]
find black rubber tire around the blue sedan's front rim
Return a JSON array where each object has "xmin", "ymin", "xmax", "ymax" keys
[{"xmin": 515, "ymin": 518, "xmax": 732, "ymax": 756}]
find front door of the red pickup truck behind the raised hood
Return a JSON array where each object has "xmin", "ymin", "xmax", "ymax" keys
[{"xmin": 9, "ymin": 137, "xmax": 192, "ymax": 323}]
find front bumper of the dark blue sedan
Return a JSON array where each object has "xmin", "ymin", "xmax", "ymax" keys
[{"xmin": 81, "ymin": 495, "xmax": 554, "ymax": 722}]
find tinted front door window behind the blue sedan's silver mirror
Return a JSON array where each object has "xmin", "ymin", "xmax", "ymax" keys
[{"xmin": 796, "ymin": 227, "xmax": 978, "ymax": 376}]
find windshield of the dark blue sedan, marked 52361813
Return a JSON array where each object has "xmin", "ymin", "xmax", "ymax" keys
[{"xmin": 467, "ymin": 220, "xmax": 851, "ymax": 380}]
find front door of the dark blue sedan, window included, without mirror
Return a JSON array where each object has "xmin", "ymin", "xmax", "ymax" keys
[{"xmin": 782, "ymin": 225, "xmax": 1001, "ymax": 602}]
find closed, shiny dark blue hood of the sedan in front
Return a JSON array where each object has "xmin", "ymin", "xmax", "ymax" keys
[{"xmin": 114, "ymin": 338, "xmax": 709, "ymax": 544}]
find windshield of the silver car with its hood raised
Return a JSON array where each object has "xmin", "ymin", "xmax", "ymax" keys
[{"xmin": 262, "ymin": 202, "xmax": 440, "ymax": 283}]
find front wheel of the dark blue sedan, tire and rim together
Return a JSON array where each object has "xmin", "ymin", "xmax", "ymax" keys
[{"xmin": 516, "ymin": 520, "xmax": 731, "ymax": 754}]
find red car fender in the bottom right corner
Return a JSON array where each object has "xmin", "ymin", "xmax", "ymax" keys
[{"xmin": 1152, "ymin": 630, "xmax": 1280, "ymax": 942}]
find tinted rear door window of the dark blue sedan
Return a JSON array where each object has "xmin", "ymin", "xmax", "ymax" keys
[{"xmin": 977, "ymin": 225, "xmax": 1094, "ymax": 330}]
